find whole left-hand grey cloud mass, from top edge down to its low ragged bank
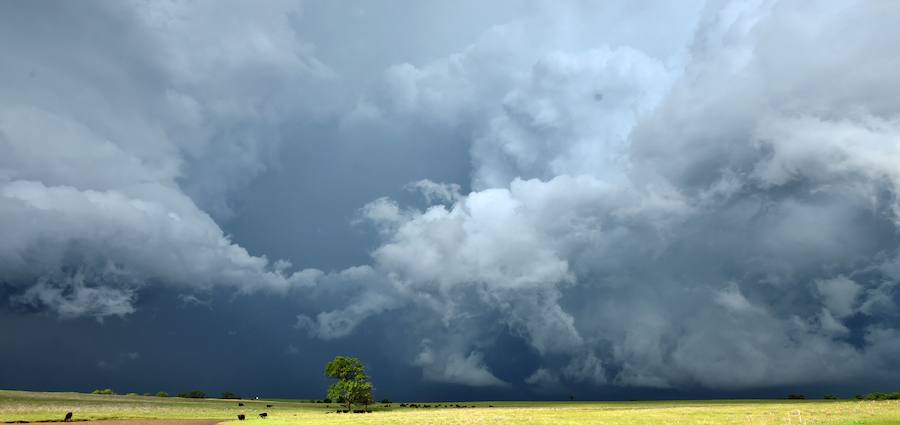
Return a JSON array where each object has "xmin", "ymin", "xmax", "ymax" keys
[{"xmin": 0, "ymin": 2, "xmax": 332, "ymax": 317}]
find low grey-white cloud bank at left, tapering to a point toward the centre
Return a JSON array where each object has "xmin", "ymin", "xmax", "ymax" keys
[{"xmin": 0, "ymin": 180, "xmax": 318, "ymax": 302}]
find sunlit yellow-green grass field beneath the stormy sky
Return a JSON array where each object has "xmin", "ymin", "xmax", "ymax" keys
[{"xmin": 0, "ymin": 391, "xmax": 900, "ymax": 425}]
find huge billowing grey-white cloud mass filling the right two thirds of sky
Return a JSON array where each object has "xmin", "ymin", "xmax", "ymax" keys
[{"xmin": 300, "ymin": 1, "xmax": 900, "ymax": 389}]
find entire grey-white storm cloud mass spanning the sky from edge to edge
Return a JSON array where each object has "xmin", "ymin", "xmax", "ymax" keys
[{"xmin": 0, "ymin": 0, "xmax": 900, "ymax": 391}]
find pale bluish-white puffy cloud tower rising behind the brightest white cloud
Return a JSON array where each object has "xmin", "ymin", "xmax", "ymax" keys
[{"xmin": 472, "ymin": 47, "xmax": 671, "ymax": 188}]
